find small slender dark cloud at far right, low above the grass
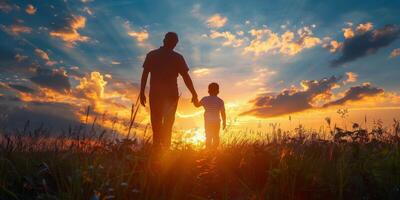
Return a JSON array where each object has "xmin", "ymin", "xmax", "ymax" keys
[{"xmin": 324, "ymin": 84, "xmax": 384, "ymax": 107}]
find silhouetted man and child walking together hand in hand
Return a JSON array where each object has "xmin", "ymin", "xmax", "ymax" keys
[{"xmin": 140, "ymin": 32, "xmax": 226, "ymax": 149}]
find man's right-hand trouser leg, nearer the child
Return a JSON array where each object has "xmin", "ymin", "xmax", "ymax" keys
[{"xmin": 161, "ymin": 98, "xmax": 178, "ymax": 148}]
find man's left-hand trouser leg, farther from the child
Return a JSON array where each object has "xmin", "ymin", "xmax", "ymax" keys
[{"xmin": 149, "ymin": 96, "xmax": 163, "ymax": 146}]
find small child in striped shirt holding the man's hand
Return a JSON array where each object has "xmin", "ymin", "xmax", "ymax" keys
[{"xmin": 193, "ymin": 83, "xmax": 226, "ymax": 149}]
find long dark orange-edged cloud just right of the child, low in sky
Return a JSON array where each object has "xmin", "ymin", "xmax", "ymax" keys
[{"xmin": 241, "ymin": 76, "xmax": 341, "ymax": 117}]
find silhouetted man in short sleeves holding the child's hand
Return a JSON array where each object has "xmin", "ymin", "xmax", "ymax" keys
[{"xmin": 140, "ymin": 32, "xmax": 197, "ymax": 148}]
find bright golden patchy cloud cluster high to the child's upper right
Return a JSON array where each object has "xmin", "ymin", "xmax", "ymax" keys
[{"xmin": 244, "ymin": 26, "xmax": 321, "ymax": 56}]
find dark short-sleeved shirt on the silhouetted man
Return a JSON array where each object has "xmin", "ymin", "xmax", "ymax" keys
[{"xmin": 143, "ymin": 47, "xmax": 189, "ymax": 98}]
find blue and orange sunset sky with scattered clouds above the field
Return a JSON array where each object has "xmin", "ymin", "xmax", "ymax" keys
[{"xmin": 0, "ymin": 0, "xmax": 400, "ymax": 137}]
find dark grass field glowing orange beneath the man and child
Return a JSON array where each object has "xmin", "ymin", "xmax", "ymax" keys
[{"xmin": 0, "ymin": 116, "xmax": 400, "ymax": 200}]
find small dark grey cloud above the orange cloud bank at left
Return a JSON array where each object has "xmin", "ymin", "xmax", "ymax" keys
[{"xmin": 31, "ymin": 68, "xmax": 71, "ymax": 93}]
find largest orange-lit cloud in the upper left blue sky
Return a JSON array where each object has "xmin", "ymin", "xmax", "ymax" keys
[{"xmin": 50, "ymin": 15, "xmax": 89, "ymax": 47}]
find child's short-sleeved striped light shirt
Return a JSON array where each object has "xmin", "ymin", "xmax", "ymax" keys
[{"xmin": 200, "ymin": 96, "xmax": 225, "ymax": 123}]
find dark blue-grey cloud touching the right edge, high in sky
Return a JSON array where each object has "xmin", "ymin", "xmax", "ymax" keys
[{"xmin": 331, "ymin": 25, "xmax": 400, "ymax": 67}]
